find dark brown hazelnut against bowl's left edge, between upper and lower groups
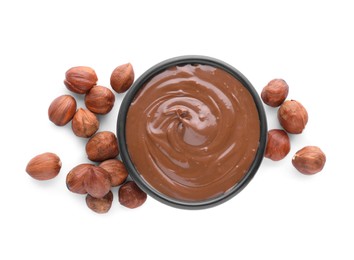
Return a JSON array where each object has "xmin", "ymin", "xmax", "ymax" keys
[{"xmin": 86, "ymin": 131, "xmax": 119, "ymax": 162}]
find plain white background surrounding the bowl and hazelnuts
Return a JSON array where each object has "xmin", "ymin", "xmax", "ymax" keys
[{"xmin": 0, "ymin": 0, "xmax": 354, "ymax": 260}]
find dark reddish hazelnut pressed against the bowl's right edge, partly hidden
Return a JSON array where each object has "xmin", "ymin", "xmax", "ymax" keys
[{"xmin": 264, "ymin": 129, "xmax": 290, "ymax": 161}]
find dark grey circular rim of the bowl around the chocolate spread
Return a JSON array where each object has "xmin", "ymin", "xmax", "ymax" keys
[{"xmin": 116, "ymin": 55, "xmax": 267, "ymax": 209}]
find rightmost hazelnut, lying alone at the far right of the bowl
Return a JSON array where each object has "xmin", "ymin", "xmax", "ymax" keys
[{"xmin": 292, "ymin": 146, "xmax": 326, "ymax": 175}]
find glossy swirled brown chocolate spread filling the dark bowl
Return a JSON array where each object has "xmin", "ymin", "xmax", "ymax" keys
[{"xmin": 126, "ymin": 65, "xmax": 260, "ymax": 201}]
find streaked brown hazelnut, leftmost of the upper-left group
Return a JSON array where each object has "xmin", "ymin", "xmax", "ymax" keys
[{"xmin": 48, "ymin": 95, "xmax": 76, "ymax": 126}]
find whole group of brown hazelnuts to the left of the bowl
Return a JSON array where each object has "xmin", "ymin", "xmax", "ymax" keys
[{"xmin": 26, "ymin": 63, "xmax": 147, "ymax": 213}]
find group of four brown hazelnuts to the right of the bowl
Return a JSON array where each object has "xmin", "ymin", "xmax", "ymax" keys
[{"xmin": 261, "ymin": 79, "xmax": 326, "ymax": 175}]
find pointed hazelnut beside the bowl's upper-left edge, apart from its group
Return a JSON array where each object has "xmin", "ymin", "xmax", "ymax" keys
[{"xmin": 111, "ymin": 63, "xmax": 134, "ymax": 93}]
